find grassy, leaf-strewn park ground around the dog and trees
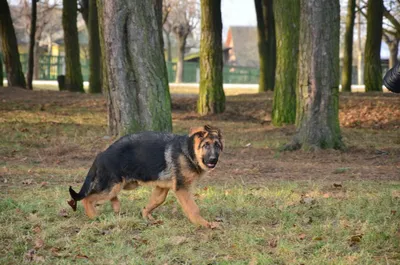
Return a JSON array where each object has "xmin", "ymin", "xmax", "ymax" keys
[{"xmin": 0, "ymin": 88, "xmax": 400, "ymax": 265}]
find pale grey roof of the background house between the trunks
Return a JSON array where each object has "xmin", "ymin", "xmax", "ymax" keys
[{"xmin": 225, "ymin": 26, "xmax": 259, "ymax": 67}]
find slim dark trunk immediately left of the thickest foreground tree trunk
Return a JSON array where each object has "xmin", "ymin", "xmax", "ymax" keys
[{"xmin": 88, "ymin": 0, "xmax": 101, "ymax": 93}]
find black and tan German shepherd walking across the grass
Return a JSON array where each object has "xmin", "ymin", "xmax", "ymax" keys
[{"xmin": 68, "ymin": 125, "xmax": 223, "ymax": 228}]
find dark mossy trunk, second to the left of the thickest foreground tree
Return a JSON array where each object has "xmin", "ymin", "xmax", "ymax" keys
[{"xmin": 62, "ymin": 0, "xmax": 85, "ymax": 92}]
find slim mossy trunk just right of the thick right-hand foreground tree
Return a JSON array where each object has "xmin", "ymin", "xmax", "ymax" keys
[{"xmin": 342, "ymin": 0, "xmax": 356, "ymax": 92}]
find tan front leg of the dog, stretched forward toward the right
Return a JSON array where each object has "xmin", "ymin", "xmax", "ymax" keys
[{"xmin": 175, "ymin": 189, "xmax": 218, "ymax": 228}]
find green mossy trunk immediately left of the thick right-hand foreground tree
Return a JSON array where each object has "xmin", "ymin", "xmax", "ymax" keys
[{"xmin": 272, "ymin": 0, "xmax": 300, "ymax": 126}]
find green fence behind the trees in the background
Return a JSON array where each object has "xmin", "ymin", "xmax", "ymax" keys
[{"xmin": 0, "ymin": 54, "xmax": 260, "ymax": 84}]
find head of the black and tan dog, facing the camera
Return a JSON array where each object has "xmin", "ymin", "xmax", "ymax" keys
[{"xmin": 189, "ymin": 125, "xmax": 224, "ymax": 171}]
